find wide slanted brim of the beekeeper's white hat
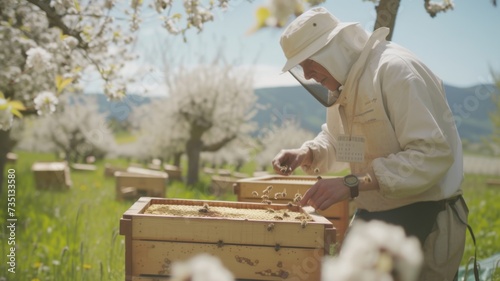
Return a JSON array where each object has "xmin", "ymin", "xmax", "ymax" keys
[{"xmin": 281, "ymin": 22, "xmax": 358, "ymax": 72}]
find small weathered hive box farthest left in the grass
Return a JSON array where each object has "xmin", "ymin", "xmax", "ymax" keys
[{"xmin": 31, "ymin": 162, "xmax": 72, "ymax": 190}]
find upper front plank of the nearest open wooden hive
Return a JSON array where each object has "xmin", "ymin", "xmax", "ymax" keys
[{"xmin": 132, "ymin": 215, "xmax": 333, "ymax": 248}]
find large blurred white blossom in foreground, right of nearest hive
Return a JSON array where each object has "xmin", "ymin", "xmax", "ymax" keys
[{"xmin": 321, "ymin": 221, "xmax": 423, "ymax": 281}]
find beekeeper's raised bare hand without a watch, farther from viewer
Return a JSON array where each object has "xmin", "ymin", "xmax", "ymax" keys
[{"xmin": 272, "ymin": 147, "xmax": 312, "ymax": 176}]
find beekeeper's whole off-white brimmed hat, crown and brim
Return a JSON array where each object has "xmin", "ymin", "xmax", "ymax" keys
[{"xmin": 280, "ymin": 7, "xmax": 357, "ymax": 72}]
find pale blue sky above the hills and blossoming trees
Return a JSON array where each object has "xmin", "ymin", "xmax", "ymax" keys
[{"xmin": 109, "ymin": 0, "xmax": 500, "ymax": 92}]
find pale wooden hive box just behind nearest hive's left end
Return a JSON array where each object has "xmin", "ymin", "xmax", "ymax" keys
[{"xmin": 115, "ymin": 171, "xmax": 168, "ymax": 201}]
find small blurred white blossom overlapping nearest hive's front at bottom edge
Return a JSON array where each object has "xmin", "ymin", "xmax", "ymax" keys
[{"xmin": 171, "ymin": 254, "xmax": 234, "ymax": 281}]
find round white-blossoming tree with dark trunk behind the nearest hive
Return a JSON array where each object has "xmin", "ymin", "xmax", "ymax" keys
[{"xmin": 135, "ymin": 62, "xmax": 256, "ymax": 185}]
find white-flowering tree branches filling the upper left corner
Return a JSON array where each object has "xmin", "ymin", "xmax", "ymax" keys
[{"xmin": 0, "ymin": 0, "xmax": 246, "ymax": 190}]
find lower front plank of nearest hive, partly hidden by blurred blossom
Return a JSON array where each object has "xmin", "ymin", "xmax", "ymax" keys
[{"xmin": 132, "ymin": 240, "xmax": 324, "ymax": 280}]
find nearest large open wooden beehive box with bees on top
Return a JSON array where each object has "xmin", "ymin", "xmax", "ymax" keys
[{"xmin": 120, "ymin": 197, "xmax": 335, "ymax": 281}]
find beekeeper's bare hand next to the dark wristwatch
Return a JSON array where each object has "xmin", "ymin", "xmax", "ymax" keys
[{"xmin": 299, "ymin": 178, "xmax": 351, "ymax": 210}]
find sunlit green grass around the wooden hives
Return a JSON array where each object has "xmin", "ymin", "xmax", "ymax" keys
[{"xmin": 0, "ymin": 152, "xmax": 500, "ymax": 281}]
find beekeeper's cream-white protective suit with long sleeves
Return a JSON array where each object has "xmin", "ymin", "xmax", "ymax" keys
[{"xmin": 281, "ymin": 8, "xmax": 468, "ymax": 281}]
